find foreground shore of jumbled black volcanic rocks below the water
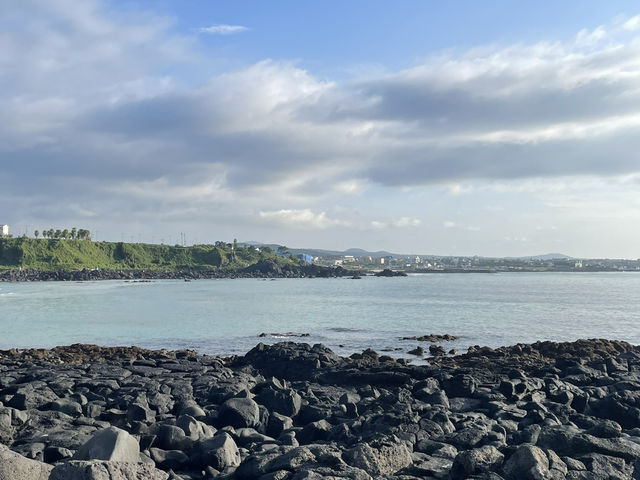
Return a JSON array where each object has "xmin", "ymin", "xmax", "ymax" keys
[{"xmin": 0, "ymin": 340, "xmax": 640, "ymax": 480}]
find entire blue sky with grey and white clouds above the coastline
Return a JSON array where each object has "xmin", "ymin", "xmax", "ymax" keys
[{"xmin": 0, "ymin": 0, "xmax": 640, "ymax": 258}]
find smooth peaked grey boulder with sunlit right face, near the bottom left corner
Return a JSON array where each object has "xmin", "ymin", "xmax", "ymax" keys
[{"xmin": 73, "ymin": 427, "xmax": 140, "ymax": 462}]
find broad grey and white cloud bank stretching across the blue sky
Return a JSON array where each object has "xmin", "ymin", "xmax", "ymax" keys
[{"xmin": 0, "ymin": 0, "xmax": 640, "ymax": 255}]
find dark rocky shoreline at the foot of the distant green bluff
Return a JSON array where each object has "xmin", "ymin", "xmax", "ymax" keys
[{"xmin": 0, "ymin": 261, "xmax": 358, "ymax": 282}]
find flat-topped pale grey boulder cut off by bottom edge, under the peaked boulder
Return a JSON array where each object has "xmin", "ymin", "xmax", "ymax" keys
[{"xmin": 49, "ymin": 460, "xmax": 169, "ymax": 480}]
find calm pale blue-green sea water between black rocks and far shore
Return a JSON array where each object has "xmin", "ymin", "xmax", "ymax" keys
[{"xmin": 0, "ymin": 273, "xmax": 640, "ymax": 356}]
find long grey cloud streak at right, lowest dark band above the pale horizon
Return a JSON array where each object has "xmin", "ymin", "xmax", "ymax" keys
[{"xmin": 367, "ymin": 127, "xmax": 640, "ymax": 186}]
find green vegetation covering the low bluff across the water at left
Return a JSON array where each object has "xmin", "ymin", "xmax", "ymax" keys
[{"xmin": 0, "ymin": 237, "xmax": 298, "ymax": 271}]
